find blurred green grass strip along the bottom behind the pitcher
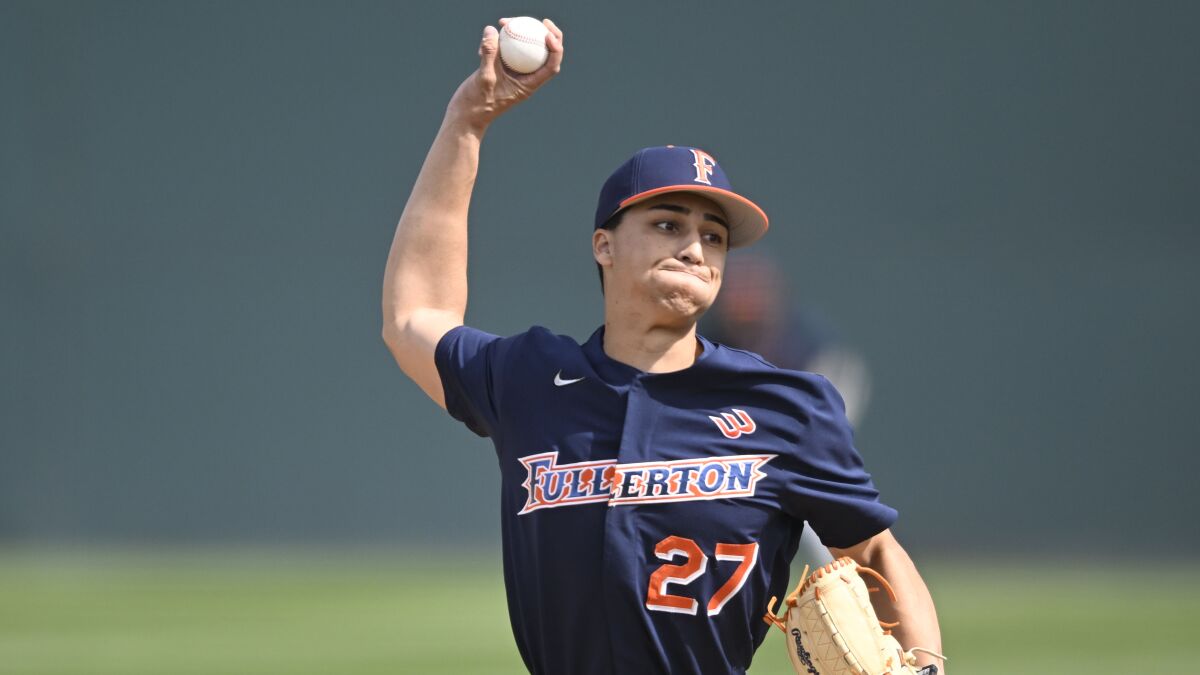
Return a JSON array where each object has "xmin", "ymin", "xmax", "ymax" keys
[{"xmin": 0, "ymin": 551, "xmax": 1200, "ymax": 675}]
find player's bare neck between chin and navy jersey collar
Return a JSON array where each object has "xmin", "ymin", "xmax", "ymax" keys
[{"xmin": 604, "ymin": 302, "xmax": 700, "ymax": 372}]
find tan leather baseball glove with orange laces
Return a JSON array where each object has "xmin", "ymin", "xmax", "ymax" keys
[{"xmin": 762, "ymin": 557, "xmax": 946, "ymax": 675}]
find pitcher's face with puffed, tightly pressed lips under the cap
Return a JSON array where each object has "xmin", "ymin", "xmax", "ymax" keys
[{"xmin": 593, "ymin": 192, "xmax": 730, "ymax": 321}]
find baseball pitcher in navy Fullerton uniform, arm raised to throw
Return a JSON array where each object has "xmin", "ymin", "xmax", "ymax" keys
[{"xmin": 383, "ymin": 19, "xmax": 941, "ymax": 675}]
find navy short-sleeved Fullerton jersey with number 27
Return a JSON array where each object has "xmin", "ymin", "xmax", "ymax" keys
[{"xmin": 436, "ymin": 327, "xmax": 896, "ymax": 675}]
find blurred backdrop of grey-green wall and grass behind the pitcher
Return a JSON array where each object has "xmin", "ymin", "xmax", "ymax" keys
[{"xmin": 0, "ymin": 0, "xmax": 1200, "ymax": 674}]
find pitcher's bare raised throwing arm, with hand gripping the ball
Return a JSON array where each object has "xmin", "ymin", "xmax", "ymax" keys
[{"xmin": 383, "ymin": 19, "xmax": 563, "ymax": 407}]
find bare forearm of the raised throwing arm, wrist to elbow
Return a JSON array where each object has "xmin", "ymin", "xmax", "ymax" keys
[{"xmin": 384, "ymin": 110, "xmax": 484, "ymax": 328}]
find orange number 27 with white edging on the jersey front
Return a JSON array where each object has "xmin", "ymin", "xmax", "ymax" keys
[{"xmin": 646, "ymin": 536, "xmax": 758, "ymax": 616}]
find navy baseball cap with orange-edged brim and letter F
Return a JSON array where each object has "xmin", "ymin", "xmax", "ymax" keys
[{"xmin": 595, "ymin": 145, "xmax": 768, "ymax": 249}]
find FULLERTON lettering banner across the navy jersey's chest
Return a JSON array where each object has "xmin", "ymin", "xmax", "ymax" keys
[{"xmin": 520, "ymin": 452, "xmax": 775, "ymax": 514}]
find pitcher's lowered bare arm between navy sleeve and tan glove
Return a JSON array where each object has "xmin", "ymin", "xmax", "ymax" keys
[{"xmin": 829, "ymin": 530, "xmax": 946, "ymax": 675}]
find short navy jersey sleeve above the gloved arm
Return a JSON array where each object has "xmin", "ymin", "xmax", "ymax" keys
[{"xmin": 782, "ymin": 376, "xmax": 898, "ymax": 548}]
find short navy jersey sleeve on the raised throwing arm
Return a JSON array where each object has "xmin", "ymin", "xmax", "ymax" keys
[{"xmin": 433, "ymin": 325, "xmax": 508, "ymax": 436}]
